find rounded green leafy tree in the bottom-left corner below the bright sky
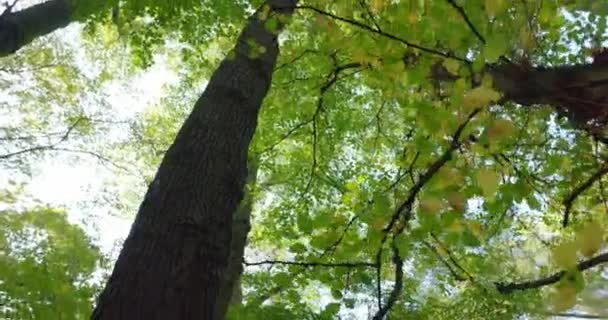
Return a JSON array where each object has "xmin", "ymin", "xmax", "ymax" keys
[{"xmin": 0, "ymin": 189, "xmax": 108, "ymax": 319}]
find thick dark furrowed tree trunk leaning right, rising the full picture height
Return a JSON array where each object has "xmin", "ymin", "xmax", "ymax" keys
[{"xmin": 92, "ymin": 0, "xmax": 297, "ymax": 320}]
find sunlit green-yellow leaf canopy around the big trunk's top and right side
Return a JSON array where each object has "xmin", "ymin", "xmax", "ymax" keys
[{"xmin": 3, "ymin": 0, "xmax": 608, "ymax": 319}]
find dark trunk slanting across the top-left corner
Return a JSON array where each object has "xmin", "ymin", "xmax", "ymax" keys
[{"xmin": 0, "ymin": 0, "xmax": 73, "ymax": 57}]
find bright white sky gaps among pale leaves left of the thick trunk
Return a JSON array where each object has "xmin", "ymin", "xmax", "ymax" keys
[{"xmin": 0, "ymin": 11, "xmax": 179, "ymax": 253}]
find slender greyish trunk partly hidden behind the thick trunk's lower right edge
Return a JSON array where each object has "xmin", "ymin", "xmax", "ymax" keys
[{"xmin": 216, "ymin": 158, "xmax": 258, "ymax": 318}]
